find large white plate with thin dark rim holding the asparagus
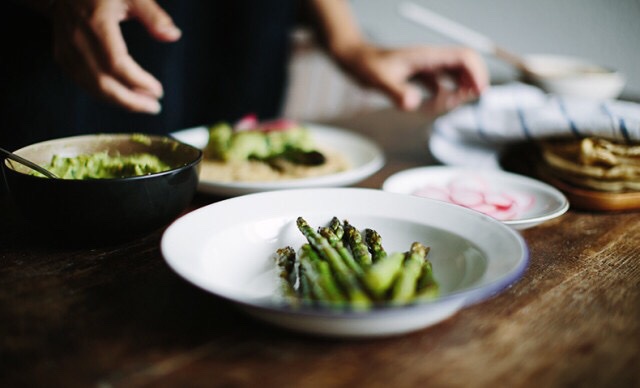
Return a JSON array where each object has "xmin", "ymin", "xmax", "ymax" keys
[{"xmin": 161, "ymin": 188, "xmax": 528, "ymax": 337}]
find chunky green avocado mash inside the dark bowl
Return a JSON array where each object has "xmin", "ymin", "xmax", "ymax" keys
[{"xmin": 33, "ymin": 152, "xmax": 171, "ymax": 179}]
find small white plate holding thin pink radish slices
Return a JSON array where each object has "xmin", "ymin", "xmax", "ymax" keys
[{"xmin": 382, "ymin": 166, "xmax": 569, "ymax": 229}]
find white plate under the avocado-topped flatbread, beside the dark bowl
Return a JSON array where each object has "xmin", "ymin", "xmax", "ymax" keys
[{"xmin": 171, "ymin": 124, "xmax": 385, "ymax": 196}]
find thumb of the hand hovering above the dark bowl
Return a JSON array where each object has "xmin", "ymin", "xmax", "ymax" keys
[{"xmin": 130, "ymin": 0, "xmax": 182, "ymax": 42}]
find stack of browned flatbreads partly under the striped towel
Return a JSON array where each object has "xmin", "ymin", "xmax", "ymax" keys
[{"xmin": 540, "ymin": 137, "xmax": 640, "ymax": 193}]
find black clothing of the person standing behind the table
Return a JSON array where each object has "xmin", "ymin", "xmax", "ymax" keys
[{"xmin": 0, "ymin": 0, "xmax": 296, "ymax": 150}]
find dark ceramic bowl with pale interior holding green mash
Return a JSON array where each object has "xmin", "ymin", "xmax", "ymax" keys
[{"xmin": 2, "ymin": 134, "xmax": 202, "ymax": 241}]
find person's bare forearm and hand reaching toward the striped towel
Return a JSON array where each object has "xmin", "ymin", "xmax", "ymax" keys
[{"xmin": 311, "ymin": 0, "xmax": 489, "ymax": 110}]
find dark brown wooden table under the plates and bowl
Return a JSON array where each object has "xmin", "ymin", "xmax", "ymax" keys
[{"xmin": 0, "ymin": 110, "xmax": 640, "ymax": 387}]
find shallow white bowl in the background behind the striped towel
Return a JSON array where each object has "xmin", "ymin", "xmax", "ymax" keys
[{"xmin": 524, "ymin": 54, "xmax": 626, "ymax": 99}]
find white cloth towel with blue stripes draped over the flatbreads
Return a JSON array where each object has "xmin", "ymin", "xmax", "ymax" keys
[{"xmin": 434, "ymin": 82, "xmax": 640, "ymax": 145}]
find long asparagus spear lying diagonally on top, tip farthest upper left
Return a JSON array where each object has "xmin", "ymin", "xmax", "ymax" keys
[{"xmin": 296, "ymin": 217, "xmax": 371, "ymax": 308}]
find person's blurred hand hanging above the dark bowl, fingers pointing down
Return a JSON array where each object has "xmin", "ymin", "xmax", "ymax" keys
[{"xmin": 50, "ymin": 0, "xmax": 181, "ymax": 114}]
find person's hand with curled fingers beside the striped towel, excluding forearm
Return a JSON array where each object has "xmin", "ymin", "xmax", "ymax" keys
[{"xmin": 338, "ymin": 45, "xmax": 489, "ymax": 111}]
